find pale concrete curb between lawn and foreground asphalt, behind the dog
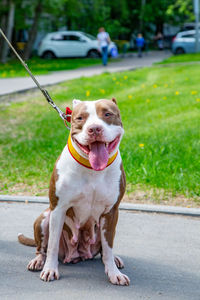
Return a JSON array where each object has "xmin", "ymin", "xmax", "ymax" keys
[{"xmin": 0, "ymin": 195, "xmax": 200, "ymax": 217}]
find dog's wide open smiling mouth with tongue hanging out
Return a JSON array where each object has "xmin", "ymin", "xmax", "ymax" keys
[{"xmin": 74, "ymin": 135, "xmax": 120, "ymax": 171}]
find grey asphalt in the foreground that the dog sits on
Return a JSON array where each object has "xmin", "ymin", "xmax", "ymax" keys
[{"xmin": 0, "ymin": 202, "xmax": 200, "ymax": 300}]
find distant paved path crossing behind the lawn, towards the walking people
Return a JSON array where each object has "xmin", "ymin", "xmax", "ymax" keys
[{"xmin": 0, "ymin": 51, "xmax": 172, "ymax": 96}]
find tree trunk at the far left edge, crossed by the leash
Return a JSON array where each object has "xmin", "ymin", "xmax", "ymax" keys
[{"xmin": 1, "ymin": 1, "xmax": 15, "ymax": 63}]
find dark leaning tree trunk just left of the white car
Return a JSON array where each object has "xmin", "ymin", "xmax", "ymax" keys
[{"xmin": 24, "ymin": 1, "xmax": 42, "ymax": 60}]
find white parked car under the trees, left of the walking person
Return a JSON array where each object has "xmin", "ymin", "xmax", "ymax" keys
[{"xmin": 38, "ymin": 31, "xmax": 117, "ymax": 59}]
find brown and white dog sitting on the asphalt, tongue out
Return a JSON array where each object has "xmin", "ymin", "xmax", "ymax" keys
[{"xmin": 18, "ymin": 98, "xmax": 130, "ymax": 285}]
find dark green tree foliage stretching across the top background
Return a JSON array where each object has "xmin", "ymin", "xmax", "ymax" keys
[{"xmin": 0, "ymin": 0, "xmax": 194, "ymax": 61}]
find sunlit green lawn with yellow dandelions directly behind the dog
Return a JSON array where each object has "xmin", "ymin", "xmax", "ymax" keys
[{"xmin": 0, "ymin": 64, "xmax": 200, "ymax": 204}]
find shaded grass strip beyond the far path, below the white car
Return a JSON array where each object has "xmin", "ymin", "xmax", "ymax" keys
[{"xmin": 0, "ymin": 57, "xmax": 104, "ymax": 78}]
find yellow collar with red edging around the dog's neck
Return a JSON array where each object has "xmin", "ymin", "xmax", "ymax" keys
[{"xmin": 67, "ymin": 134, "xmax": 118, "ymax": 169}]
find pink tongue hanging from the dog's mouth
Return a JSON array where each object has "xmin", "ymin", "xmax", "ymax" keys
[{"xmin": 89, "ymin": 142, "xmax": 108, "ymax": 171}]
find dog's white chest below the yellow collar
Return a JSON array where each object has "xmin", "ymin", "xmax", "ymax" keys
[{"xmin": 56, "ymin": 151, "xmax": 121, "ymax": 225}]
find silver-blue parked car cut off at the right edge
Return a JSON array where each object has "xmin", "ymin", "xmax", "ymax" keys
[{"xmin": 172, "ymin": 30, "xmax": 200, "ymax": 54}]
